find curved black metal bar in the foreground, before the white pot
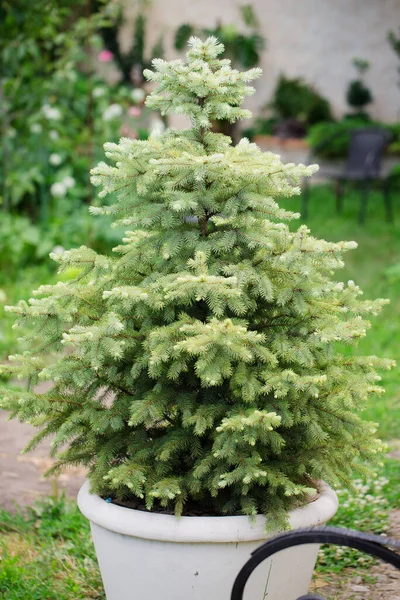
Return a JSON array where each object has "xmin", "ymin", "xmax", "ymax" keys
[{"xmin": 231, "ymin": 527, "xmax": 400, "ymax": 600}]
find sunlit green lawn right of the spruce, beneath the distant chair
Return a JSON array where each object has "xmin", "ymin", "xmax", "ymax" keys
[{"xmin": 282, "ymin": 186, "xmax": 400, "ymax": 439}]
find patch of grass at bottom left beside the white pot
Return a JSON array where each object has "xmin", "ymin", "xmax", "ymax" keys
[{"xmin": 0, "ymin": 498, "xmax": 105, "ymax": 600}]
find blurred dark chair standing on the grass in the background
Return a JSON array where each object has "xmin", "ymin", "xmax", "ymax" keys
[{"xmin": 302, "ymin": 127, "xmax": 393, "ymax": 223}]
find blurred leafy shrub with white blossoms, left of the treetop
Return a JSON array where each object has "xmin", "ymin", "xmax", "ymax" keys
[{"xmin": 0, "ymin": 0, "xmax": 149, "ymax": 223}]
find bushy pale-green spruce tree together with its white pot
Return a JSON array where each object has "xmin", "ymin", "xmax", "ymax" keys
[{"xmin": 0, "ymin": 37, "xmax": 390, "ymax": 600}]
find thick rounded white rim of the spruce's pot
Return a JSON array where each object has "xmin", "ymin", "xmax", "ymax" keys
[{"xmin": 78, "ymin": 480, "xmax": 338, "ymax": 543}]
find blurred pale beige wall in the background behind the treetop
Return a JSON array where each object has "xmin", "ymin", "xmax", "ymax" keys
[{"xmin": 123, "ymin": 0, "xmax": 400, "ymax": 122}]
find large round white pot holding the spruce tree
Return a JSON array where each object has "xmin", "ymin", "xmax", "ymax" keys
[{"xmin": 78, "ymin": 482, "xmax": 338, "ymax": 600}]
